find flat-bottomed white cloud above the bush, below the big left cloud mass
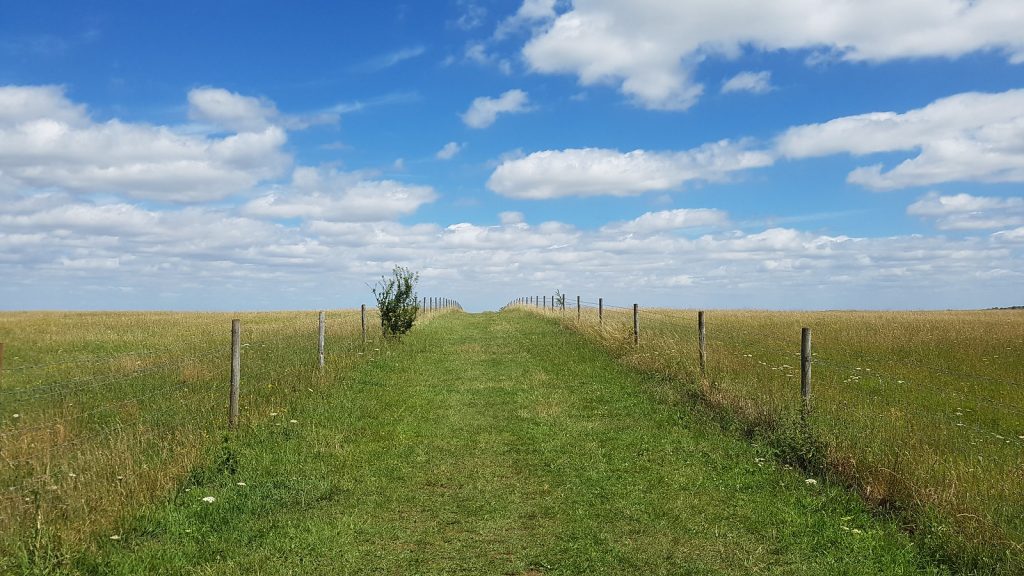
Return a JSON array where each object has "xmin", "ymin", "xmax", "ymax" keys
[{"xmin": 243, "ymin": 167, "xmax": 437, "ymax": 222}]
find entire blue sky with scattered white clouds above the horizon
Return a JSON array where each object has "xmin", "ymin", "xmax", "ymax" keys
[{"xmin": 0, "ymin": 0, "xmax": 1024, "ymax": 311}]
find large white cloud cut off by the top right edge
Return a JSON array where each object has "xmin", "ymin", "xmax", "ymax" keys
[{"xmin": 522, "ymin": 0, "xmax": 1024, "ymax": 110}]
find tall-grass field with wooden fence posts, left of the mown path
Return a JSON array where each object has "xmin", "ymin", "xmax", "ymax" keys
[{"xmin": 0, "ymin": 297, "xmax": 458, "ymax": 561}]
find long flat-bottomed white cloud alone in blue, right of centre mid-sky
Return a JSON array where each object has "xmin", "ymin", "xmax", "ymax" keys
[{"xmin": 487, "ymin": 140, "xmax": 772, "ymax": 200}]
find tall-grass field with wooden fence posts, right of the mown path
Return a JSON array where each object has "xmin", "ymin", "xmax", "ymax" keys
[{"xmin": 508, "ymin": 294, "xmax": 1024, "ymax": 569}]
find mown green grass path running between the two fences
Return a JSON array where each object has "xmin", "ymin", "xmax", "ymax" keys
[{"xmin": 73, "ymin": 312, "xmax": 942, "ymax": 575}]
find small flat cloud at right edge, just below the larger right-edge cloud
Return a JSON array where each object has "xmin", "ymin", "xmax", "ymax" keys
[{"xmin": 906, "ymin": 192, "xmax": 1024, "ymax": 230}]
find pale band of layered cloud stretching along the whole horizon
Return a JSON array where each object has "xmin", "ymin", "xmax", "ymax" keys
[{"xmin": 0, "ymin": 192, "xmax": 1024, "ymax": 310}]
